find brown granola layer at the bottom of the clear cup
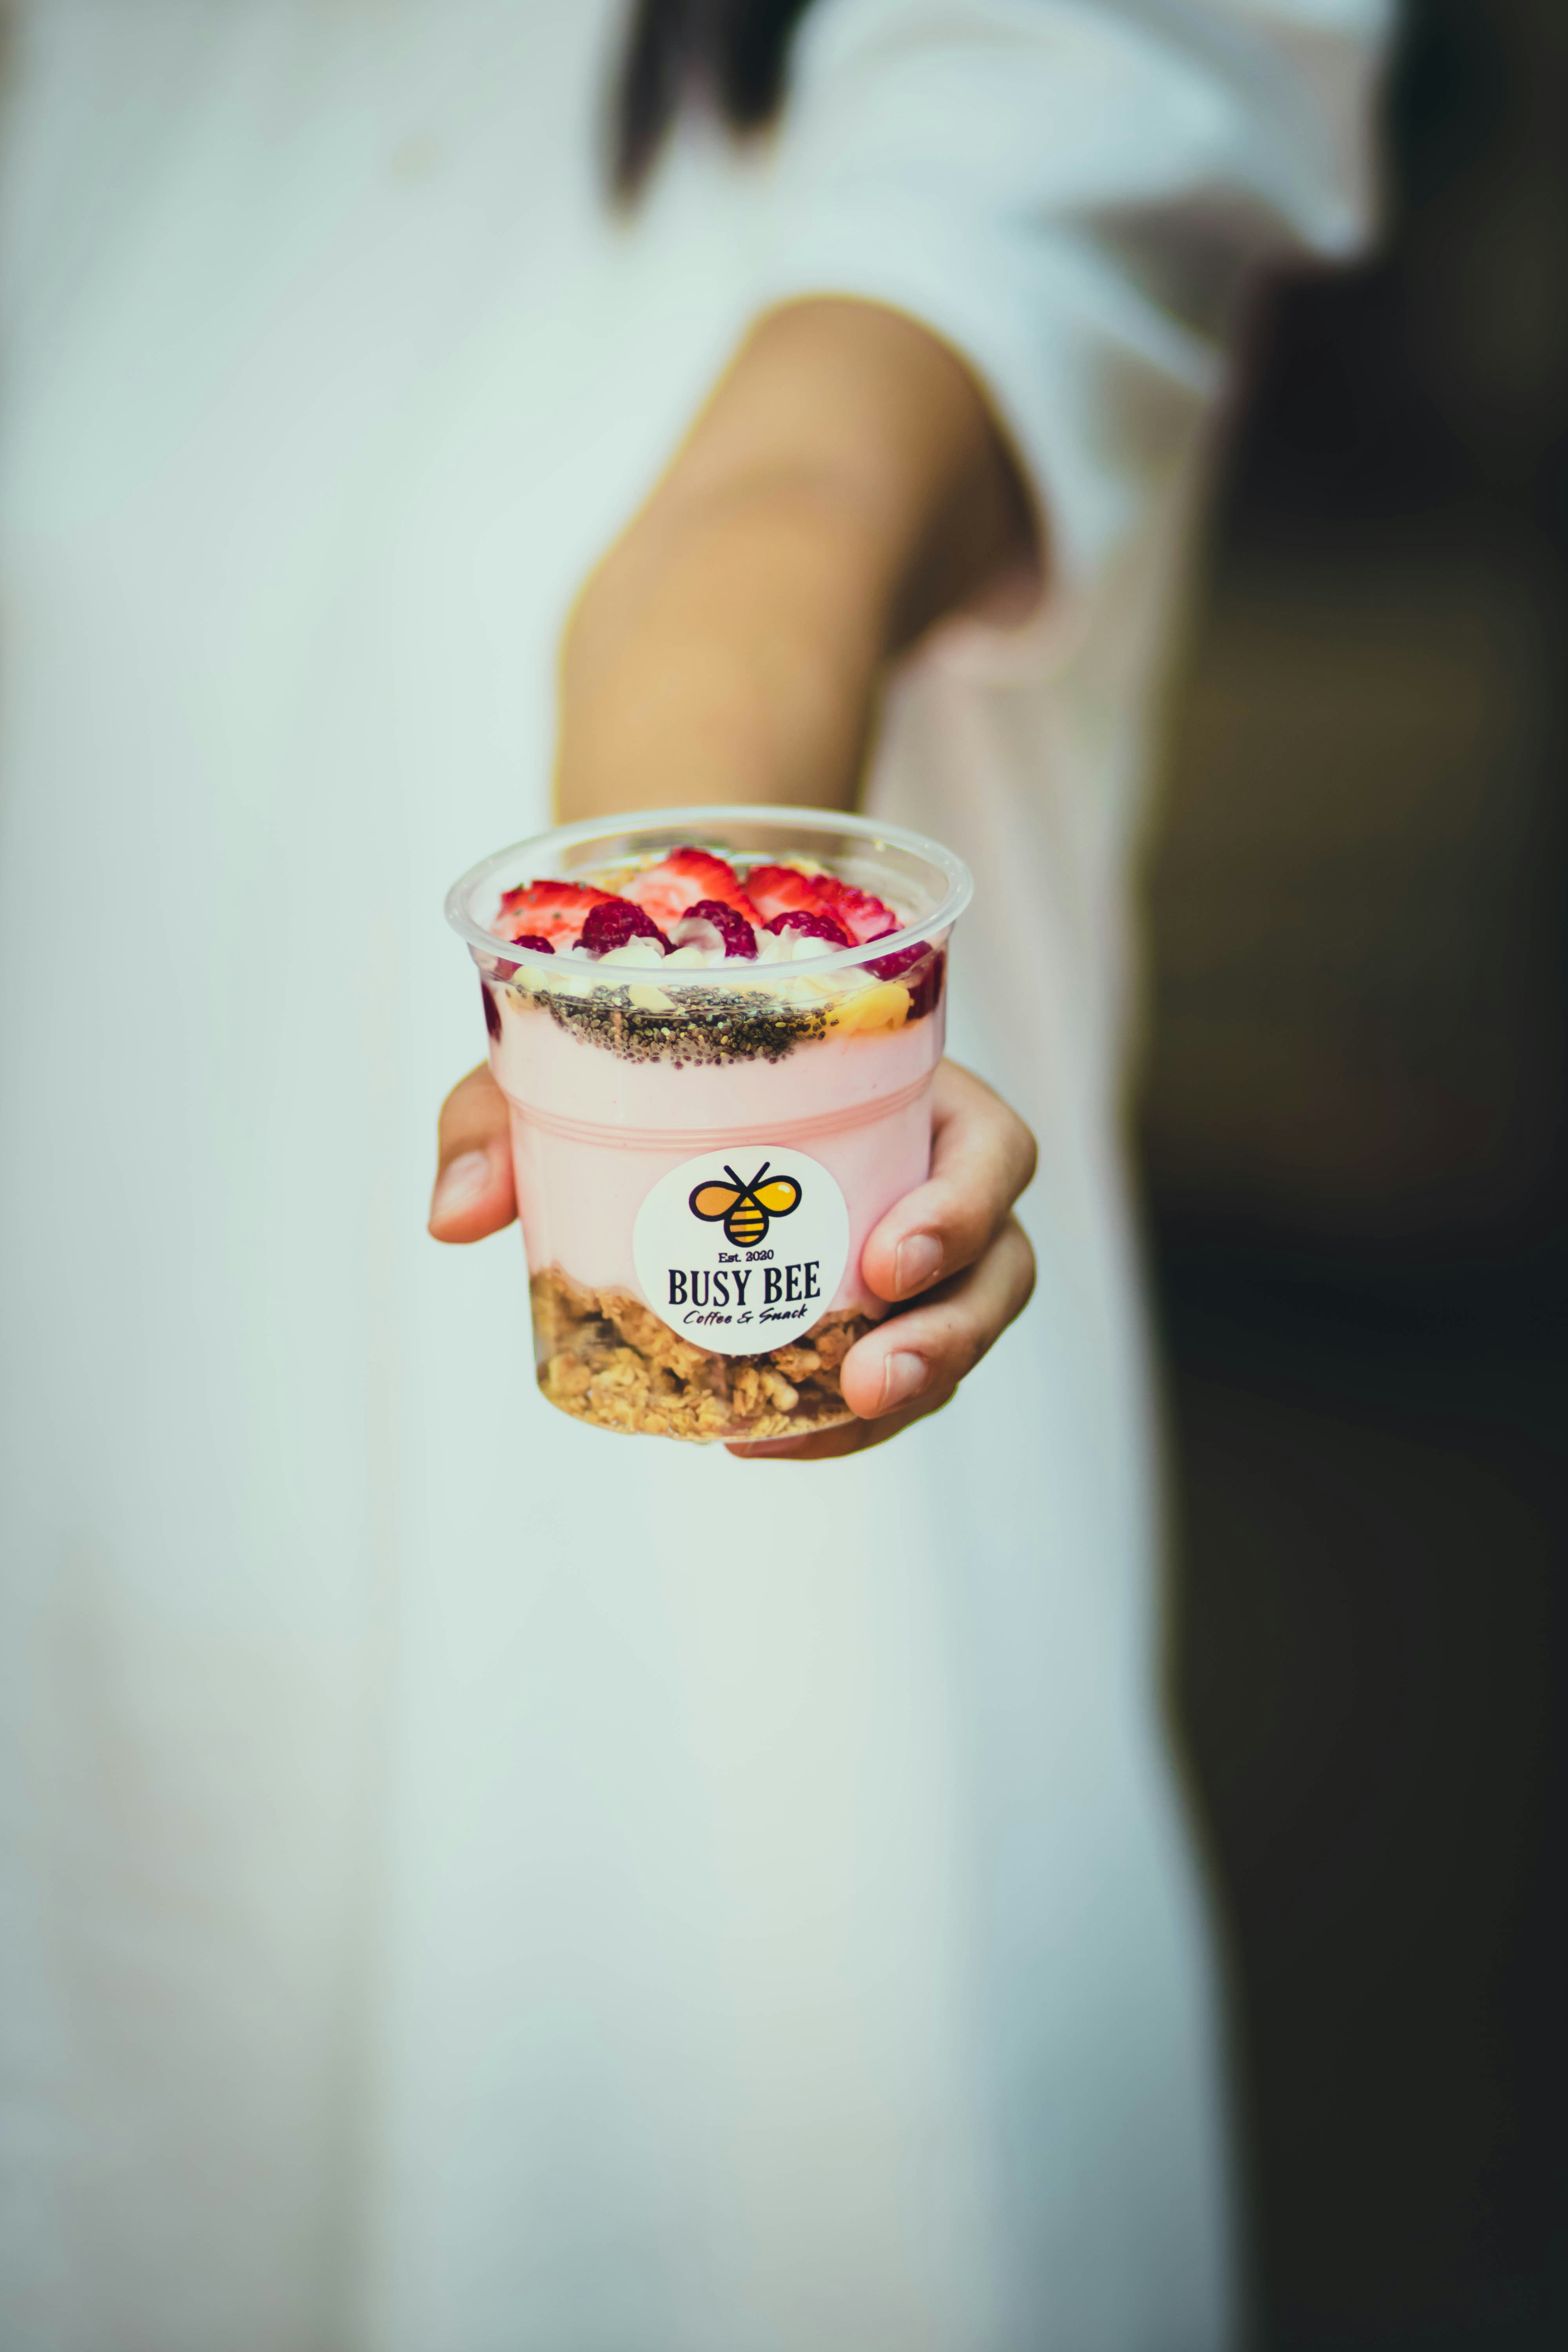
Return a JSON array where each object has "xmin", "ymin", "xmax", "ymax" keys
[{"xmin": 531, "ymin": 1268, "xmax": 872, "ymax": 1444}]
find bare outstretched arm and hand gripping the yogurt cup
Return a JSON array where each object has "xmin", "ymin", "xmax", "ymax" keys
[{"xmin": 430, "ymin": 301, "xmax": 1034, "ymax": 1456}]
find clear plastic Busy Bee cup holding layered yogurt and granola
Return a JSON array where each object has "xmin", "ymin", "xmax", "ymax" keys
[{"xmin": 446, "ymin": 807, "xmax": 971, "ymax": 1442}]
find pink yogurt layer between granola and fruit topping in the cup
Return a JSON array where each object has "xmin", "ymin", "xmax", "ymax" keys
[{"xmin": 491, "ymin": 988, "xmax": 943, "ymax": 1315}]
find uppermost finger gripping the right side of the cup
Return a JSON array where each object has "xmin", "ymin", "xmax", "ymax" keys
[{"xmin": 860, "ymin": 1061, "xmax": 1034, "ymax": 1301}]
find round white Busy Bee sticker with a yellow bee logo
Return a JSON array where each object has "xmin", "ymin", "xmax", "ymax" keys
[{"xmin": 632, "ymin": 1143, "xmax": 849, "ymax": 1355}]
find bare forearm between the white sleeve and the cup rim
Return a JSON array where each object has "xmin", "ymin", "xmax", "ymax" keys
[{"xmin": 557, "ymin": 301, "xmax": 1027, "ymax": 818}]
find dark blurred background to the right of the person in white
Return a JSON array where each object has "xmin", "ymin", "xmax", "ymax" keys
[{"xmin": 1143, "ymin": 0, "xmax": 1568, "ymax": 2352}]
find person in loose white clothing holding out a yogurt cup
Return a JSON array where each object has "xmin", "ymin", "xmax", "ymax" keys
[{"xmin": 0, "ymin": 0, "xmax": 1382, "ymax": 2352}]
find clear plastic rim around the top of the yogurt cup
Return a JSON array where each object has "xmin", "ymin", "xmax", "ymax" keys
[{"xmin": 444, "ymin": 802, "xmax": 976, "ymax": 988}]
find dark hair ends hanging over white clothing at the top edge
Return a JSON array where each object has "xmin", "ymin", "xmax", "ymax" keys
[{"xmin": 613, "ymin": 0, "xmax": 811, "ymax": 202}]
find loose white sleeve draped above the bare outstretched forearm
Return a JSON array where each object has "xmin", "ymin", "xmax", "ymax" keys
[{"xmin": 759, "ymin": 0, "xmax": 1389, "ymax": 583}]
